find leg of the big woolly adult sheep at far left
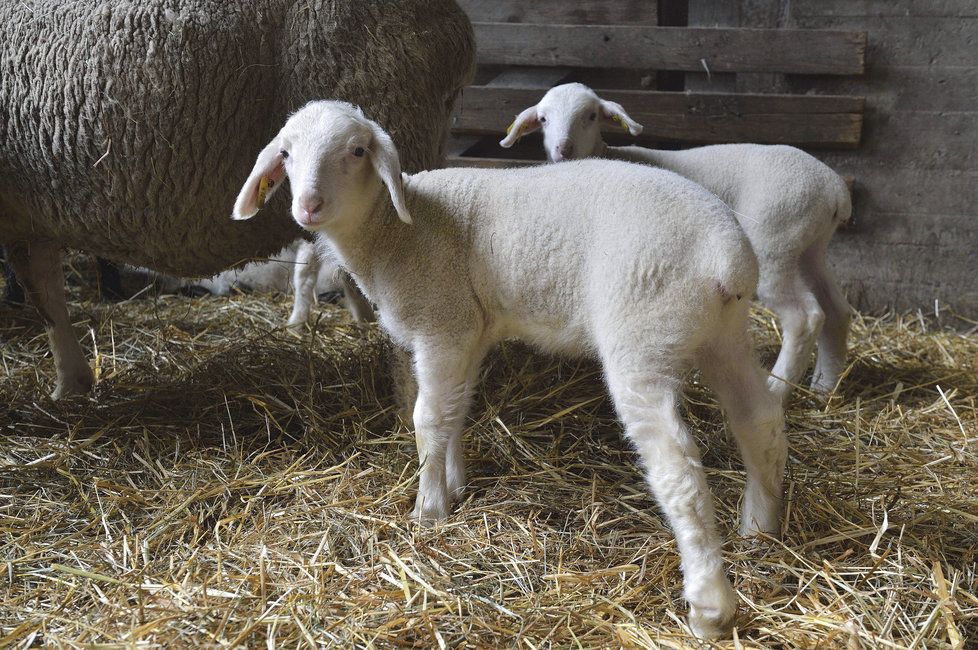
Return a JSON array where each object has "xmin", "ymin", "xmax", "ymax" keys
[{"xmin": 7, "ymin": 241, "xmax": 95, "ymax": 399}]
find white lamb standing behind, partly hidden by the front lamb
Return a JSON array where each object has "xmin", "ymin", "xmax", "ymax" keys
[{"xmin": 499, "ymin": 83, "xmax": 852, "ymax": 401}]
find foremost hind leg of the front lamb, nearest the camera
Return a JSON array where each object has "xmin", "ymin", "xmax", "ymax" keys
[{"xmin": 604, "ymin": 349, "xmax": 737, "ymax": 639}]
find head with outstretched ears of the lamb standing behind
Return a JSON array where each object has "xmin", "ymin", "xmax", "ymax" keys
[{"xmin": 499, "ymin": 83, "xmax": 642, "ymax": 162}]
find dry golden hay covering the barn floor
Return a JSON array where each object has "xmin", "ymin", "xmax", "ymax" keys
[{"xmin": 0, "ymin": 260, "xmax": 978, "ymax": 648}]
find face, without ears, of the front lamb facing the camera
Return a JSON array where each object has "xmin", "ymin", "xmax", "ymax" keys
[{"xmin": 281, "ymin": 105, "xmax": 380, "ymax": 231}]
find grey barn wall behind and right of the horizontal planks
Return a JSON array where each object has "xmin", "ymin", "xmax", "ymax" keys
[{"xmin": 687, "ymin": 0, "xmax": 978, "ymax": 318}]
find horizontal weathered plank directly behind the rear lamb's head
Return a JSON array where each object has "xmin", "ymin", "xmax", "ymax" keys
[{"xmin": 453, "ymin": 86, "xmax": 863, "ymax": 147}]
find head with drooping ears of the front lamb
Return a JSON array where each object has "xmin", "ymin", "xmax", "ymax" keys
[{"xmin": 231, "ymin": 101, "xmax": 411, "ymax": 231}]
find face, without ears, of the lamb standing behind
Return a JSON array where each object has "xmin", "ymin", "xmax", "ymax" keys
[{"xmin": 537, "ymin": 84, "xmax": 603, "ymax": 162}]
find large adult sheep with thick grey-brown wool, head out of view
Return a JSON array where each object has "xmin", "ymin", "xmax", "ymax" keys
[{"xmin": 0, "ymin": 0, "xmax": 474, "ymax": 399}]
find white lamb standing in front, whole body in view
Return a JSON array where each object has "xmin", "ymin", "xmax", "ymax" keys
[{"xmin": 233, "ymin": 101, "xmax": 786, "ymax": 637}]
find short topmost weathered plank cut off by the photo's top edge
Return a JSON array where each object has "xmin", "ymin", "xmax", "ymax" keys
[{"xmin": 458, "ymin": 0, "xmax": 658, "ymax": 26}]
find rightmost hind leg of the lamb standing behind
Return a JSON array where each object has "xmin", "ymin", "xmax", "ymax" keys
[{"xmin": 805, "ymin": 248, "xmax": 852, "ymax": 393}]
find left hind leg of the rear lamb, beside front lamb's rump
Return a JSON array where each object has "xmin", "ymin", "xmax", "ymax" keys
[{"xmin": 758, "ymin": 268, "xmax": 825, "ymax": 403}]
